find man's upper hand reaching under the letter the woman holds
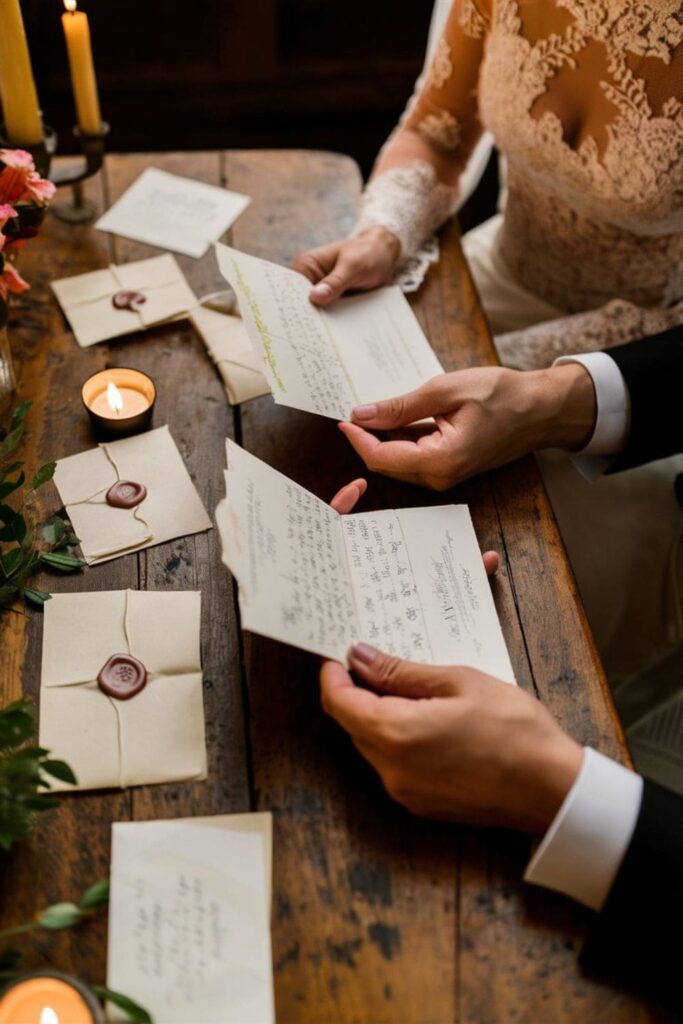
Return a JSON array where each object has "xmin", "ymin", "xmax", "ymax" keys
[{"xmin": 339, "ymin": 362, "xmax": 596, "ymax": 490}]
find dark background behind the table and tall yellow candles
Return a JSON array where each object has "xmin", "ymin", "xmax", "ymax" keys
[{"xmin": 23, "ymin": 0, "xmax": 432, "ymax": 171}]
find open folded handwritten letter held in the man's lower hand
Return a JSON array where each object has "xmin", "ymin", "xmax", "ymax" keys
[{"xmin": 216, "ymin": 440, "xmax": 514, "ymax": 682}]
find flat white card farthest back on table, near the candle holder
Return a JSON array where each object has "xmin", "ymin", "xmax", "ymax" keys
[{"xmin": 95, "ymin": 167, "xmax": 251, "ymax": 258}]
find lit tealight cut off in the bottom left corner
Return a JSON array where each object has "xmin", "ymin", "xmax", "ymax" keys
[{"xmin": 0, "ymin": 971, "xmax": 104, "ymax": 1024}]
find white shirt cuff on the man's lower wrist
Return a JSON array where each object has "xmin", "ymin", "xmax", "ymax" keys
[{"xmin": 524, "ymin": 746, "xmax": 643, "ymax": 910}]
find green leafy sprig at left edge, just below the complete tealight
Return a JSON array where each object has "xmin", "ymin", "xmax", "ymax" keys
[{"xmin": 0, "ymin": 401, "xmax": 85, "ymax": 608}]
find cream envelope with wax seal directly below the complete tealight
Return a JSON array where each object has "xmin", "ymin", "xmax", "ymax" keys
[{"xmin": 54, "ymin": 427, "xmax": 211, "ymax": 565}]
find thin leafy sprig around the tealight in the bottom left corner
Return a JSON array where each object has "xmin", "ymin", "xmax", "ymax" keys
[{"xmin": 0, "ymin": 879, "xmax": 153, "ymax": 1024}]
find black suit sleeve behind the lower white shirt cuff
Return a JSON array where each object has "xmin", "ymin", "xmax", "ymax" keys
[{"xmin": 581, "ymin": 780, "xmax": 683, "ymax": 1007}]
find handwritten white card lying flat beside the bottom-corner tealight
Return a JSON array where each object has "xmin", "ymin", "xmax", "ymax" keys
[{"xmin": 108, "ymin": 814, "xmax": 274, "ymax": 1024}]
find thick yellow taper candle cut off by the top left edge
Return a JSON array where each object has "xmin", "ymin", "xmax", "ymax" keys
[{"xmin": 0, "ymin": 0, "xmax": 43, "ymax": 145}]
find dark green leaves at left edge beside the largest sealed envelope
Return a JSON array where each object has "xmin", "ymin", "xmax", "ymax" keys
[{"xmin": 0, "ymin": 700, "xmax": 76, "ymax": 850}]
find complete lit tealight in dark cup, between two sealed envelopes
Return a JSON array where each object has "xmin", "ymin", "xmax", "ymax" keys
[{"xmin": 81, "ymin": 367, "xmax": 157, "ymax": 437}]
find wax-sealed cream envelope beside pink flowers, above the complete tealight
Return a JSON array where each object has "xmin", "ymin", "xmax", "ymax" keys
[{"xmin": 52, "ymin": 253, "xmax": 197, "ymax": 348}]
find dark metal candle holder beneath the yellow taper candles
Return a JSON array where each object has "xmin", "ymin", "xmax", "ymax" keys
[{"xmin": 0, "ymin": 121, "xmax": 110, "ymax": 224}]
